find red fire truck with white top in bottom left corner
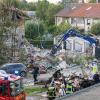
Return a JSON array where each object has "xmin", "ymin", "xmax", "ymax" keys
[{"xmin": 0, "ymin": 74, "xmax": 26, "ymax": 100}]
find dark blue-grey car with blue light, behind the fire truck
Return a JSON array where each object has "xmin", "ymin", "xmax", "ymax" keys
[{"xmin": 0, "ymin": 63, "xmax": 27, "ymax": 77}]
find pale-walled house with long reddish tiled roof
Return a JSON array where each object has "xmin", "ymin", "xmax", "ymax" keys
[{"xmin": 55, "ymin": 3, "xmax": 100, "ymax": 32}]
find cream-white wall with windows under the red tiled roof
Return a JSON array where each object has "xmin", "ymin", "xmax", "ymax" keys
[{"xmin": 55, "ymin": 17, "xmax": 100, "ymax": 32}]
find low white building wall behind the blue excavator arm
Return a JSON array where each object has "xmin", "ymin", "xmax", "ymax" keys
[{"xmin": 54, "ymin": 37, "xmax": 95, "ymax": 55}]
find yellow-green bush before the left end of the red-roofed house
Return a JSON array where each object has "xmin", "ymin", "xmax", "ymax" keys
[{"xmin": 56, "ymin": 22, "xmax": 71, "ymax": 34}]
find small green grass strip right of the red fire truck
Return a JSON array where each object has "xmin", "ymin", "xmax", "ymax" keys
[{"xmin": 24, "ymin": 87, "xmax": 47, "ymax": 96}]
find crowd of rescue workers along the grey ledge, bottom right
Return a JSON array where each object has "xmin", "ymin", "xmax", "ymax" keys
[{"xmin": 47, "ymin": 60, "xmax": 100, "ymax": 100}]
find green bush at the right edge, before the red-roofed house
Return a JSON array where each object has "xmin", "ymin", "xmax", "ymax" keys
[{"xmin": 90, "ymin": 22, "xmax": 100, "ymax": 35}]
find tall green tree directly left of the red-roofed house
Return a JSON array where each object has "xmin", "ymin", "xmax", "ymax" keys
[{"xmin": 36, "ymin": 0, "xmax": 63, "ymax": 33}]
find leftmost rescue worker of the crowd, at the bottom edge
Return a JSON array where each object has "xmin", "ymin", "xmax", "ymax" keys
[{"xmin": 47, "ymin": 86, "xmax": 56, "ymax": 100}]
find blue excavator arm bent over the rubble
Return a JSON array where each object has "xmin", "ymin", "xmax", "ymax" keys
[{"xmin": 50, "ymin": 28, "xmax": 96, "ymax": 55}]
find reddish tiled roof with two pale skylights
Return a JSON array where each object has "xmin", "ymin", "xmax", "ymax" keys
[{"xmin": 55, "ymin": 3, "xmax": 100, "ymax": 18}]
